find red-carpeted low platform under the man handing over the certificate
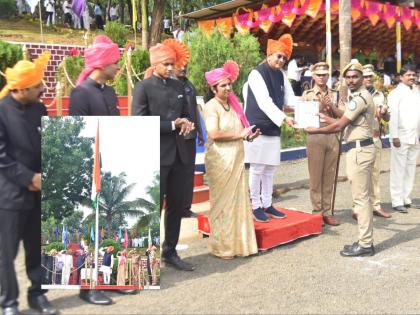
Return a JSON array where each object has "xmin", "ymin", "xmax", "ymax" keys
[{"xmin": 197, "ymin": 208, "xmax": 322, "ymax": 250}]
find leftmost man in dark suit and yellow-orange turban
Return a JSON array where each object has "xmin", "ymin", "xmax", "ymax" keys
[{"xmin": 0, "ymin": 53, "xmax": 57, "ymax": 315}]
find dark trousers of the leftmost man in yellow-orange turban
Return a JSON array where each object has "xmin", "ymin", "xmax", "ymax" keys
[{"xmin": 0, "ymin": 208, "xmax": 46, "ymax": 308}]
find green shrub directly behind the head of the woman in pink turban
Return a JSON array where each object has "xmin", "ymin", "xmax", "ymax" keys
[{"xmin": 188, "ymin": 29, "xmax": 262, "ymax": 100}]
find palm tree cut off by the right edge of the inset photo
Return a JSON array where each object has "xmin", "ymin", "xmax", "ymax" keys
[{"xmin": 133, "ymin": 173, "xmax": 160, "ymax": 235}]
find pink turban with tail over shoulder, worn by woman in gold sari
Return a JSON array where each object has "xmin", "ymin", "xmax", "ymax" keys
[{"xmin": 204, "ymin": 60, "xmax": 249, "ymax": 128}]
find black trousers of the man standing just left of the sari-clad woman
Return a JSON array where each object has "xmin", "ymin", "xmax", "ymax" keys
[{"xmin": 160, "ymin": 152, "xmax": 188, "ymax": 257}]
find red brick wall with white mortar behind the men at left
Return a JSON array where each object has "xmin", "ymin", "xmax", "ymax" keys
[{"xmin": 6, "ymin": 42, "xmax": 123, "ymax": 97}]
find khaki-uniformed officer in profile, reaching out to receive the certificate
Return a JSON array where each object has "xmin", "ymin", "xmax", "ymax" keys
[{"xmin": 306, "ymin": 60, "xmax": 376, "ymax": 257}]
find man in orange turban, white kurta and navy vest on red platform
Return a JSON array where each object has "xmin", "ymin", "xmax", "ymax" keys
[{"xmin": 245, "ymin": 34, "xmax": 295, "ymax": 222}]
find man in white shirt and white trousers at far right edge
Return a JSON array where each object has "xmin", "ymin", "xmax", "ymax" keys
[{"xmin": 388, "ymin": 66, "xmax": 420, "ymax": 213}]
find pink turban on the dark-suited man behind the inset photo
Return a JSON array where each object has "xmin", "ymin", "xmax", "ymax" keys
[{"xmin": 76, "ymin": 35, "xmax": 120, "ymax": 85}]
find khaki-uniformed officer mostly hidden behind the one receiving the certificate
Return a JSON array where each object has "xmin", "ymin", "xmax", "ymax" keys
[{"xmin": 363, "ymin": 64, "xmax": 392, "ymax": 218}]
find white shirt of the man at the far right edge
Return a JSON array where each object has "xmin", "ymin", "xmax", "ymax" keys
[{"xmin": 388, "ymin": 83, "xmax": 420, "ymax": 144}]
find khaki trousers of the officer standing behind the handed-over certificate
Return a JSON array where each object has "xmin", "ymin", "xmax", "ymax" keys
[{"xmin": 306, "ymin": 134, "xmax": 339, "ymax": 216}]
